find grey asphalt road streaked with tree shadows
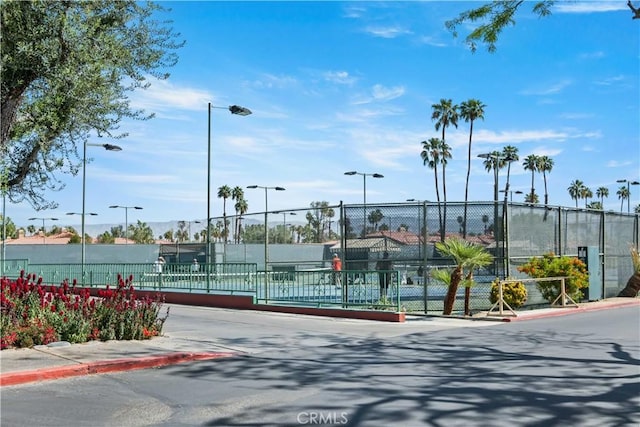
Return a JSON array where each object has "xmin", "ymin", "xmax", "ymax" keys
[{"xmin": 0, "ymin": 307, "xmax": 640, "ymax": 427}]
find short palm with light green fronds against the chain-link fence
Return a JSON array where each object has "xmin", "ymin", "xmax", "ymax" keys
[{"xmin": 436, "ymin": 238, "xmax": 493, "ymax": 315}]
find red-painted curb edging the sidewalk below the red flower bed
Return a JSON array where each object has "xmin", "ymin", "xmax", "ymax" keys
[{"xmin": 0, "ymin": 353, "xmax": 235, "ymax": 387}]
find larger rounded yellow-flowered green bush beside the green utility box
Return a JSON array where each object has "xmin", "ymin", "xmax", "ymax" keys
[{"xmin": 518, "ymin": 253, "xmax": 589, "ymax": 303}]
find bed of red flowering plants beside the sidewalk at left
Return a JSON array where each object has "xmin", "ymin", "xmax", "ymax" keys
[{"xmin": 0, "ymin": 271, "xmax": 169, "ymax": 349}]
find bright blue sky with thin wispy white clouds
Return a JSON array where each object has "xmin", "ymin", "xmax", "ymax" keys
[{"xmin": 7, "ymin": 0, "xmax": 640, "ymax": 232}]
